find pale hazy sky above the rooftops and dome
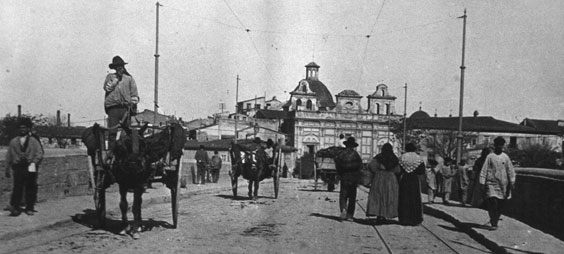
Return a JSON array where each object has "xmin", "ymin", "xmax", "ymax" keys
[{"xmin": 0, "ymin": 0, "xmax": 564, "ymax": 126}]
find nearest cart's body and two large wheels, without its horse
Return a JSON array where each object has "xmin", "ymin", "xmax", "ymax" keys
[{"xmin": 83, "ymin": 123, "xmax": 185, "ymax": 228}]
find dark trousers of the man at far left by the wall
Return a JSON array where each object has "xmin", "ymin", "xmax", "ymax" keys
[{"xmin": 10, "ymin": 166, "xmax": 37, "ymax": 210}]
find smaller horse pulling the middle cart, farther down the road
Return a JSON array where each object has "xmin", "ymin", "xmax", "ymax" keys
[{"xmin": 229, "ymin": 143, "xmax": 276, "ymax": 200}]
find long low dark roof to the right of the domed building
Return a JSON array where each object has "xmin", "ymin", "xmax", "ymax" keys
[{"xmin": 407, "ymin": 116, "xmax": 553, "ymax": 135}]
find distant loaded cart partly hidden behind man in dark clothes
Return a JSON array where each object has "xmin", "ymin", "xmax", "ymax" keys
[{"xmin": 314, "ymin": 146, "xmax": 344, "ymax": 191}]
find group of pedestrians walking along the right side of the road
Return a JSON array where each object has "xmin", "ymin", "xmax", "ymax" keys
[{"xmin": 335, "ymin": 137, "xmax": 515, "ymax": 230}]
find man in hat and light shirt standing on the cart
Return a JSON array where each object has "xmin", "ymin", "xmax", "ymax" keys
[{"xmin": 104, "ymin": 56, "xmax": 139, "ymax": 160}]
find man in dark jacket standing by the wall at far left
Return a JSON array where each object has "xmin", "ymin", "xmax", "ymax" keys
[{"xmin": 5, "ymin": 118, "xmax": 43, "ymax": 216}]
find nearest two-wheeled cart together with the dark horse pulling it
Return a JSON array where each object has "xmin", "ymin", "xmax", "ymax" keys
[{"xmin": 83, "ymin": 120, "xmax": 186, "ymax": 231}]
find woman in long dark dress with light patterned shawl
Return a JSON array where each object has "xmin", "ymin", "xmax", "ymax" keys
[{"xmin": 398, "ymin": 143, "xmax": 425, "ymax": 226}]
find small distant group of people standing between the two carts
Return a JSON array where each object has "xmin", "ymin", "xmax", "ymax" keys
[{"xmin": 194, "ymin": 145, "xmax": 223, "ymax": 184}]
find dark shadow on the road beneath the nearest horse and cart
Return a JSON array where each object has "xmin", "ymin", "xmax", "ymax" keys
[{"xmin": 71, "ymin": 209, "xmax": 174, "ymax": 234}]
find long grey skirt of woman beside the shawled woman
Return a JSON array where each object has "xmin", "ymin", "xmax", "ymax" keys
[{"xmin": 366, "ymin": 171, "xmax": 399, "ymax": 218}]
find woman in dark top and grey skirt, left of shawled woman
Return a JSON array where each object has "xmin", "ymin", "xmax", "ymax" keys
[{"xmin": 366, "ymin": 143, "xmax": 400, "ymax": 224}]
